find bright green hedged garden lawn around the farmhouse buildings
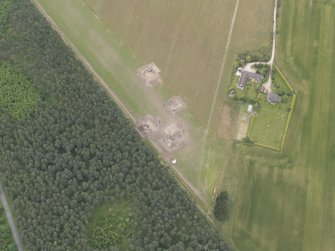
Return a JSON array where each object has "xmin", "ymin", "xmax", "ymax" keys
[{"xmin": 228, "ymin": 65, "xmax": 295, "ymax": 150}]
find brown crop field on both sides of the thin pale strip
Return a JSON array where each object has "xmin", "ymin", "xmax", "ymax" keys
[{"xmin": 84, "ymin": 0, "xmax": 272, "ymax": 123}]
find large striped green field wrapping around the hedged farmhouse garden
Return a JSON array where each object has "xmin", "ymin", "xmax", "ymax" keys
[{"xmin": 223, "ymin": 0, "xmax": 335, "ymax": 251}]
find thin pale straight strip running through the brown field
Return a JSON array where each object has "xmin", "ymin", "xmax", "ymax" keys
[{"xmin": 204, "ymin": 0, "xmax": 240, "ymax": 139}]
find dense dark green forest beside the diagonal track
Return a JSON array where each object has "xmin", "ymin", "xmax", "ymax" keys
[{"xmin": 0, "ymin": 0, "xmax": 229, "ymax": 251}]
